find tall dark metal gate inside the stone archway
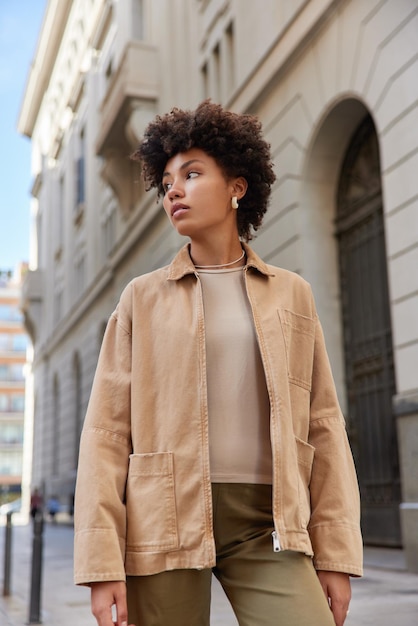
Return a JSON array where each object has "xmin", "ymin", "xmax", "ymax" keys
[{"xmin": 336, "ymin": 116, "xmax": 400, "ymax": 546}]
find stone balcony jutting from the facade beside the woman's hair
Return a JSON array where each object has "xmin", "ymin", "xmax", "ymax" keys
[{"xmin": 96, "ymin": 40, "xmax": 158, "ymax": 215}]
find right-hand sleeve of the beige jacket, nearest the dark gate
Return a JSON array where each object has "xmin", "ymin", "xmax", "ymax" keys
[{"xmin": 309, "ymin": 302, "xmax": 363, "ymax": 576}]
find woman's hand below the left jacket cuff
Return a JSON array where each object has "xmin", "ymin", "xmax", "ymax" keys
[{"xmin": 91, "ymin": 580, "xmax": 134, "ymax": 626}]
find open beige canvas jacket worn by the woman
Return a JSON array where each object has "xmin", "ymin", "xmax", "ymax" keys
[{"xmin": 75, "ymin": 241, "xmax": 362, "ymax": 584}]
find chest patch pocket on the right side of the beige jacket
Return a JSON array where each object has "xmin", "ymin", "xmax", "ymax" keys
[{"xmin": 278, "ymin": 309, "xmax": 315, "ymax": 391}]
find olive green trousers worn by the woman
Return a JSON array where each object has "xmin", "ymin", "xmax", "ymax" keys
[{"xmin": 127, "ymin": 483, "xmax": 334, "ymax": 626}]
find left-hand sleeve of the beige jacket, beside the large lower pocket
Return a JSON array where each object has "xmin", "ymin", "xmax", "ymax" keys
[{"xmin": 74, "ymin": 286, "xmax": 131, "ymax": 584}]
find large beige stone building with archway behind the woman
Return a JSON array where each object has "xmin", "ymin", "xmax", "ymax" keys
[{"xmin": 19, "ymin": 0, "xmax": 418, "ymax": 570}]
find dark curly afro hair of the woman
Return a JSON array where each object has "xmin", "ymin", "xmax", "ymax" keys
[{"xmin": 131, "ymin": 100, "xmax": 276, "ymax": 241}]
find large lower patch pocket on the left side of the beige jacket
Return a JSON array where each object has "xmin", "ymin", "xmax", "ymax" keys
[{"xmin": 126, "ymin": 452, "xmax": 179, "ymax": 552}]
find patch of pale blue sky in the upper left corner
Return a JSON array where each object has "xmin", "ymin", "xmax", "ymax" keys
[{"xmin": 0, "ymin": 0, "xmax": 47, "ymax": 270}]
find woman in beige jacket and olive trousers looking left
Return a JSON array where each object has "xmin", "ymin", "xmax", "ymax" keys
[{"xmin": 75, "ymin": 101, "xmax": 362, "ymax": 626}]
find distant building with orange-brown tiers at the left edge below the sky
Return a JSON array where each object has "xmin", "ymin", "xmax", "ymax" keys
[{"xmin": 0, "ymin": 265, "xmax": 29, "ymax": 505}]
